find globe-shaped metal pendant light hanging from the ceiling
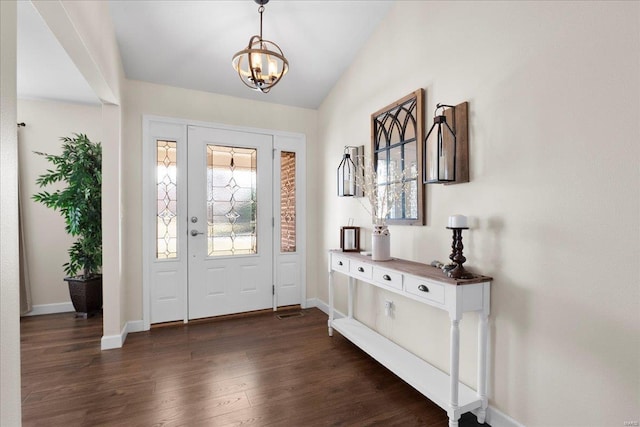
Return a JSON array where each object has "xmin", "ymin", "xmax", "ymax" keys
[{"xmin": 232, "ymin": 0, "xmax": 289, "ymax": 93}]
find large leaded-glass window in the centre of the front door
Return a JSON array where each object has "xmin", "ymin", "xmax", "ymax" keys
[{"xmin": 207, "ymin": 145, "xmax": 258, "ymax": 256}]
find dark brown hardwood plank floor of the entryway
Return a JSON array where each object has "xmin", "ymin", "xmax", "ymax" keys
[{"xmin": 21, "ymin": 309, "xmax": 488, "ymax": 427}]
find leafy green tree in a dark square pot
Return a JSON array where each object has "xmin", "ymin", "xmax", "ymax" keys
[{"xmin": 32, "ymin": 134, "xmax": 102, "ymax": 318}]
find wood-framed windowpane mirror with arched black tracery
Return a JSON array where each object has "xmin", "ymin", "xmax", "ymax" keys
[{"xmin": 371, "ymin": 89, "xmax": 425, "ymax": 225}]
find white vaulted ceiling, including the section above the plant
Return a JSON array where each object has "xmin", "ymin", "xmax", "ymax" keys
[{"xmin": 18, "ymin": 0, "xmax": 393, "ymax": 109}]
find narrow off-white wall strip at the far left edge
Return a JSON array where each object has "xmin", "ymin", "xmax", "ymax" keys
[{"xmin": 0, "ymin": 1, "xmax": 22, "ymax": 427}]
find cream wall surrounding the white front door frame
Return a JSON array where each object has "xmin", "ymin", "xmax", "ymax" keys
[{"xmin": 123, "ymin": 81, "xmax": 320, "ymax": 320}]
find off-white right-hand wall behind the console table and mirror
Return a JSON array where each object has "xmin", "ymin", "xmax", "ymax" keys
[{"xmin": 318, "ymin": 1, "xmax": 640, "ymax": 426}]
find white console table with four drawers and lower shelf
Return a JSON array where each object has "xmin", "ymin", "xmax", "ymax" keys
[{"xmin": 329, "ymin": 251, "xmax": 492, "ymax": 427}]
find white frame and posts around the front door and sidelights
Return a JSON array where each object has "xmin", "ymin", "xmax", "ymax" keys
[{"xmin": 142, "ymin": 115, "xmax": 306, "ymax": 330}]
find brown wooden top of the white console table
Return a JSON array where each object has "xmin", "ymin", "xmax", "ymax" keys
[{"xmin": 330, "ymin": 249, "xmax": 493, "ymax": 285}]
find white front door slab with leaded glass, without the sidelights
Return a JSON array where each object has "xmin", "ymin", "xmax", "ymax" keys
[{"xmin": 187, "ymin": 126, "xmax": 273, "ymax": 319}]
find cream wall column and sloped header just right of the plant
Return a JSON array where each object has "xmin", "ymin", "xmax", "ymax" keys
[{"xmin": 32, "ymin": 0, "xmax": 127, "ymax": 342}]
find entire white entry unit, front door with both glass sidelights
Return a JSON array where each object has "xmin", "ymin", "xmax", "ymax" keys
[{"xmin": 143, "ymin": 117, "xmax": 306, "ymax": 329}]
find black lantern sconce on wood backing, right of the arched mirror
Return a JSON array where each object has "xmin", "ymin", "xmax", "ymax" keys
[{"xmin": 422, "ymin": 102, "xmax": 469, "ymax": 184}]
